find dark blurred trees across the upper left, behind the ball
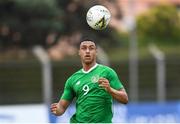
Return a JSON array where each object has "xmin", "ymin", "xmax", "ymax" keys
[{"xmin": 0, "ymin": 0, "xmax": 125, "ymax": 49}]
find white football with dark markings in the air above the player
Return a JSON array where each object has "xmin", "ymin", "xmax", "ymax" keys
[{"xmin": 86, "ymin": 5, "xmax": 111, "ymax": 30}]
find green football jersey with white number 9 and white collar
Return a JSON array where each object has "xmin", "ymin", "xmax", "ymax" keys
[{"xmin": 61, "ymin": 64, "xmax": 123, "ymax": 123}]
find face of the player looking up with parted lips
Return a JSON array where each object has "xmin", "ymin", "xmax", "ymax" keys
[{"xmin": 79, "ymin": 41, "xmax": 97, "ymax": 64}]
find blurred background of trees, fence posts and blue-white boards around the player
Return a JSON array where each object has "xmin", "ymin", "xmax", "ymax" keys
[{"xmin": 0, "ymin": 0, "xmax": 180, "ymax": 122}]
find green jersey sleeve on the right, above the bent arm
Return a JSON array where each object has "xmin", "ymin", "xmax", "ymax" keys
[{"xmin": 109, "ymin": 69, "xmax": 124, "ymax": 90}]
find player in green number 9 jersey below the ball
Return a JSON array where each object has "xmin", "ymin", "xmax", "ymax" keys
[{"xmin": 51, "ymin": 41, "xmax": 128, "ymax": 123}]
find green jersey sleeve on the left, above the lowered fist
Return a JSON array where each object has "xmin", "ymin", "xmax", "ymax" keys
[{"xmin": 61, "ymin": 78, "xmax": 75, "ymax": 101}]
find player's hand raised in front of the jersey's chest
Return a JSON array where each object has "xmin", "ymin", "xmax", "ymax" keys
[{"xmin": 98, "ymin": 78, "xmax": 111, "ymax": 91}]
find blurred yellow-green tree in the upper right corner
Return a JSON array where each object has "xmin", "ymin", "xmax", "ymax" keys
[{"xmin": 137, "ymin": 4, "xmax": 180, "ymax": 44}]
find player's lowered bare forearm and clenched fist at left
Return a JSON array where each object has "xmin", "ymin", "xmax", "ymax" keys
[{"xmin": 51, "ymin": 100, "xmax": 70, "ymax": 116}]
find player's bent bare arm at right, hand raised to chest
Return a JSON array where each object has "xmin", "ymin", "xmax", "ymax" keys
[{"xmin": 98, "ymin": 78, "xmax": 128, "ymax": 104}]
